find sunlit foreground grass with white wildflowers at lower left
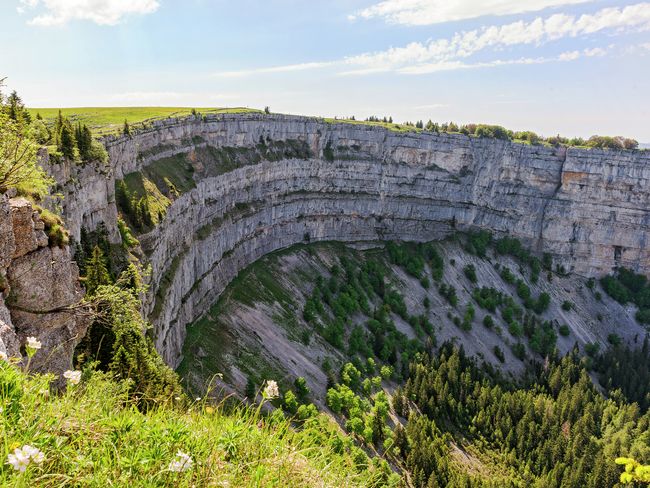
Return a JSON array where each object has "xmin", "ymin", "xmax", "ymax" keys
[{"xmin": 0, "ymin": 360, "xmax": 390, "ymax": 487}]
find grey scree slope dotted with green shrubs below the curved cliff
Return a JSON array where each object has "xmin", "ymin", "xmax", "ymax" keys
[{"xmin": 179, "ymin": 234, "xmax": 646, "ymax": 405}]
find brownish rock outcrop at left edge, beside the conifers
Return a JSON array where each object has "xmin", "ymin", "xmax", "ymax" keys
[{"xmin": 0, "ymin": 195, "xmax": 88, "ymax": 373}]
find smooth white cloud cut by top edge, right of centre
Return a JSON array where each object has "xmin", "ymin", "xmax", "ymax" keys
[{"xmin": 349, "ymin": 0, "xmax": 592, "ymax": 25}]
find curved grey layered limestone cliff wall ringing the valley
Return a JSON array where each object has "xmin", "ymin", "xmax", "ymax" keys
[{"xmin": 44, "ymin": 114, "xmax": 650, "ymax": 365}]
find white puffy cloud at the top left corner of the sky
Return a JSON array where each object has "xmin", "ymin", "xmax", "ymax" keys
[{"xmin": 18, "ymin": 0, "xmax": 160, "ymax": 26}]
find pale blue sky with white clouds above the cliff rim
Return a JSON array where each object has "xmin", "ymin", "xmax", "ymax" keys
[{"xmin": 0, "ymin": 0, "xmax": 650, "ymax": 143}]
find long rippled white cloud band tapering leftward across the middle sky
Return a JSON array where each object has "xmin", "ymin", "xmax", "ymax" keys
[{"xmin": 204, "ymin": 2, "xmax": 632, "ymax": 77}]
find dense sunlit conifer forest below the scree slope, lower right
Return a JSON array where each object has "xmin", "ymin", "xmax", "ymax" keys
[{"xmin": 396, "ymin": 345, "xmax": 650, "ymax": 487}]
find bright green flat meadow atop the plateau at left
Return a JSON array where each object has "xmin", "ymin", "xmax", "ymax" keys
[{"xmin": 28, "ymin": 107, "xmax": 261, "ymax": 135}]
